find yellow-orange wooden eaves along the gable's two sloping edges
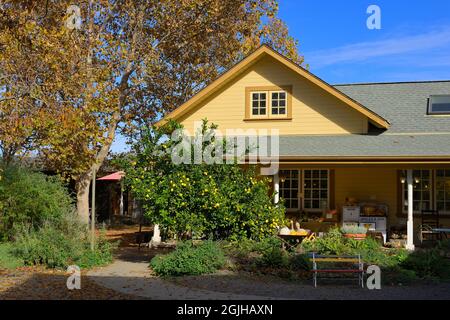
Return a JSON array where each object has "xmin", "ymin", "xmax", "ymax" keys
[{"xmin": 156, "ymin": 45, "xmax": 389, "ymax": 129}]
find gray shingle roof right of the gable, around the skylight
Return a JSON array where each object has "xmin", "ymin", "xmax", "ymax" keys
[{"xmin": 280, "ymin": 81, "xmax": 450, "ymax": 158}]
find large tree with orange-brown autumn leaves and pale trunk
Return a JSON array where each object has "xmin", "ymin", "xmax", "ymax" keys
[{"xmin": 0, "ymin": 0, "xmax": 303, "ymax": 221}]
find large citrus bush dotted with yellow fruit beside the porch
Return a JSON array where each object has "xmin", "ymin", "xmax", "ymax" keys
[{"xmin": 121, "ymin": 121, "xmax": 284, "ymax": 239}]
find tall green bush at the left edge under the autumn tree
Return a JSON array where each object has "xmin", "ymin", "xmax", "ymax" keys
[{"xmin": 0, "ymin": 166, "xmax": 73, "ymax": 240}]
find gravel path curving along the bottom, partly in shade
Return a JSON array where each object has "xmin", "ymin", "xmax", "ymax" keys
[{"xmin": 87, "ymin": 250, "xmax": 450, "ymax": 300}]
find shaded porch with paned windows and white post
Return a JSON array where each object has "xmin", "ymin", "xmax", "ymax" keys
[{"xmin": 273, "ymin": 162, "xmax": 450, "ymax": 250}]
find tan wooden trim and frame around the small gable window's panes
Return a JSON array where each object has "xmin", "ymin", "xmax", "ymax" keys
[{"xmin": 244, "ymin": 85, "xmax": 292, "ymax": 121}]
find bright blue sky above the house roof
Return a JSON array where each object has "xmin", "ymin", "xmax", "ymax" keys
[{"xmin": 113, "ymin": 0, "xmax": 450, "ymax": 152}]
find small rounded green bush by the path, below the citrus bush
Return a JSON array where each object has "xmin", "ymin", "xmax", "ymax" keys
[{"xmin": 150, "ymin": 241, "xmax": 225, "ymax": 276}]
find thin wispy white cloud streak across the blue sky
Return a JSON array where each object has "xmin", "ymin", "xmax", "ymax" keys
[{"xmin": 305, "ymin": 26, "xmax": 450, "ymax": 69}]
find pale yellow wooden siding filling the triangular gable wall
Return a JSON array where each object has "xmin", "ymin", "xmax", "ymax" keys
[{"xmin": 180, "ymin": 57, "xmax": 368, "ymax": 135}]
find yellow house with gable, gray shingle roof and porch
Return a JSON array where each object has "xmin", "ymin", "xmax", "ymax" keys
[{"xmin": 158, "ymin": 46, "xmax": 450, "ymax": 249}]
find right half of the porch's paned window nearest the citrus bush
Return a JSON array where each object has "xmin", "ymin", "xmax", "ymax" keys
[{"xmin": 303, "ymin": 170, "xmax": 328, "ymax": 210}]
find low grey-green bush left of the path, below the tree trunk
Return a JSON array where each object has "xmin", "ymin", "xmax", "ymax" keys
[{"xmin": 13, "ymin": 214, "xmax": 114, "ymax": 268}]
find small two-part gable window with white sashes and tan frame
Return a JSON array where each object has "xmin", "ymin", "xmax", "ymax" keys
[{"xmin": 245, "ymin": 86, "xmax": 292, "ymax": 120}]
